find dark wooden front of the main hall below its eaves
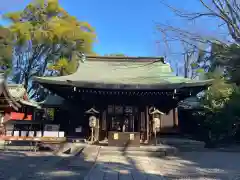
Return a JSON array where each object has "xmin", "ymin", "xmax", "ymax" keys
[{"xmin": 49, "ymin": 97, "xmax": 178, "ymax": 146}]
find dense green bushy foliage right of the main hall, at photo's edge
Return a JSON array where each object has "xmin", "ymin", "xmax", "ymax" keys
[{"xmin": 201, "ymin": 69, "xmax": 240, "ymax": 141}]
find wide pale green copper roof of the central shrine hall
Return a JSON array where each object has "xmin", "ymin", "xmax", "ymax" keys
[{"xmin": 35, "ymin": 56, "xmax": 210, "ymax": 89}]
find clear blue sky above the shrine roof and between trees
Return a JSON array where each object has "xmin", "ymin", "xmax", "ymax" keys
[{"xmin": 0, "ymin": 0, "xmax": 226, "ymax": 58}]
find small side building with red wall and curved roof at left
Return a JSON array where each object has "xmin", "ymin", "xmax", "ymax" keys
[{"xmin": 0, "ymin": 74, "xmax": 40, "ymax": 136}]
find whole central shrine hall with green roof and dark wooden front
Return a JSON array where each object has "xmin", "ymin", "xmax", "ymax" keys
[{"xmin": 34, "ymin": 56, "xmax": 211, "ymax": 146}]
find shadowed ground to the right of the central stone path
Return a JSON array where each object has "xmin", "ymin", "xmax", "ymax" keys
[{"xmin": 148, "ymin": 151, "xmax": 240, "ymax": 180}]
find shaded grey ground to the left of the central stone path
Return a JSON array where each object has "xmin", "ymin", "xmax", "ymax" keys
[{"xmin": 0, "ymin": 146, "xmax": 98, "ymax": 180}]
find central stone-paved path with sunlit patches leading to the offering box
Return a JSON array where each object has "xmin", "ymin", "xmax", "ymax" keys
[{"xmin": 85, "ymin": 154, "xmax": 164, "ymax": 180}]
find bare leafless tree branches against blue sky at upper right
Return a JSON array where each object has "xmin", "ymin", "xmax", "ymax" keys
[{"xmin": 157, "ymin": 0, "xmax": 240, "ymax": 77}]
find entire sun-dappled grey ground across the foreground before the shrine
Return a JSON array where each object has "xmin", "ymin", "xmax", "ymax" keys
[{"xmin": 0, "ymin": 152, "xmax": 240, "ymax": 180}]
